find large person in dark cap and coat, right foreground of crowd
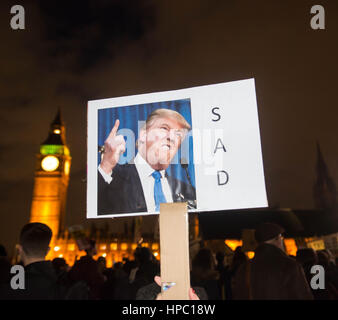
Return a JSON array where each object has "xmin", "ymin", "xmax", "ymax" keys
[{"xmin": 234, "ymin": 223, "xmax": 313, "ymax": 300}]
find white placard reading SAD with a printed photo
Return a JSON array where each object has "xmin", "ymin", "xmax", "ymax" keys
[{"xmin": 87, "ymin": 79, "xmax": 268, "ymax": 218}]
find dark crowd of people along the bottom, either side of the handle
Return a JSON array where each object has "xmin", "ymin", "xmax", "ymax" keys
[{"xmin": 0, "ymin": 223, "xmax": 338, "ymax": 300}]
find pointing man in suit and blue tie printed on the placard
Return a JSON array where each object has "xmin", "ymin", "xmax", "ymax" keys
[{"xmin": 97, "ymin": 108, "xmax": 196, "ymax": 215}]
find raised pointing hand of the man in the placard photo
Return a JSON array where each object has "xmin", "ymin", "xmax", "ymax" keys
[{"xmin": 100, "ymin": 119, "xmax": 126, "ymax": 174}]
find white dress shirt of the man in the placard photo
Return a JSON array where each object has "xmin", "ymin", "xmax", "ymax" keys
[{"xmin": 98, "ymin": 153, "xmax": 173, "ymax": 213}]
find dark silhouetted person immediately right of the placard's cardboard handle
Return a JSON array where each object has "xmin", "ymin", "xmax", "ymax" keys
[{"xmin": 191, "ymin": 248, "xmax": 221, "ymax": 300}]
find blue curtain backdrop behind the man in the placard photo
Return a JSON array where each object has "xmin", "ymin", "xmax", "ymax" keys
[{"xmin": 98, "ymin": 99, "xmax": 195, "ymax": 187}]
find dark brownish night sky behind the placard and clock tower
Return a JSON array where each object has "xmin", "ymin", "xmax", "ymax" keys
[{"xmin": 0, "ymin": 0, "xmax": 338, "ymax": 252}]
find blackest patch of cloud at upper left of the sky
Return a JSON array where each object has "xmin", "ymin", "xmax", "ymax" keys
[{"xmin": 38, "ymin": 0, "xmax": 155, "ymax": 72}]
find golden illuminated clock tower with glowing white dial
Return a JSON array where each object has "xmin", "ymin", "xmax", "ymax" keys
[{"xmin": 30, "ymin": 110, "xmax": 71, "ymax": 244}]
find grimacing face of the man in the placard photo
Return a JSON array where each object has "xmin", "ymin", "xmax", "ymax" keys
[{"xmin": 139, "ymin": 117, "xmax": 187, "ymax": 170}]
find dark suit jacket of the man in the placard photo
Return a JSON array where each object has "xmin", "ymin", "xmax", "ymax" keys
[{"xmin": 97, "ymin": 164, "xmax": 196, "ymax": 215}]
